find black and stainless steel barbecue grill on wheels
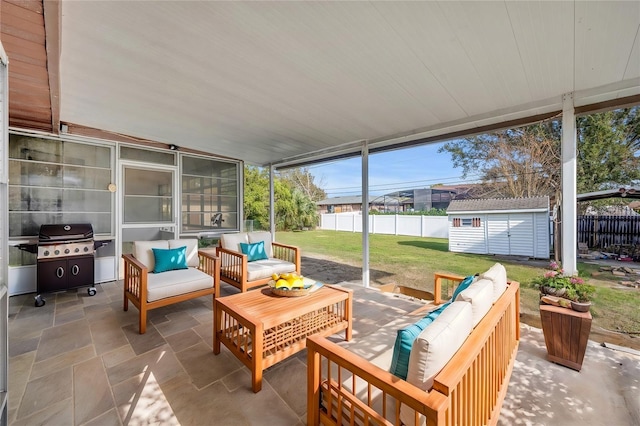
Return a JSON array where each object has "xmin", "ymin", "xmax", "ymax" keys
[{"xmin": 35, "ymin": 223, "xmax": 96, "ymax": 307}]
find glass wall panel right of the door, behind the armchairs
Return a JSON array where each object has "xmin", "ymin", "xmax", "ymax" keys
[{"xmin": 181, "ymin": 155, "xmax": 240, "ymax": 233}]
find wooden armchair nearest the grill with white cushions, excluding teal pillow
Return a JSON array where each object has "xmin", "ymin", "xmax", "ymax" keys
[{"xmin": 122, "ymin": 239, "xmax": 220, "ymax": 334}]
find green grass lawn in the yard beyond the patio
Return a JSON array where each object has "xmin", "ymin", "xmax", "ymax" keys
[{"xmin": 276, "ymin": 230, "xmax": 640, "ymax": 345}]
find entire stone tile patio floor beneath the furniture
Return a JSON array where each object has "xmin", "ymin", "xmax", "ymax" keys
[{"xmin": 9, "ymin": 274, "xmax": 640, "ymax": 425}]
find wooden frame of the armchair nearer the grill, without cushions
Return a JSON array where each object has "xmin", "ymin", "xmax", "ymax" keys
[{"xmin": 122, "ymin": 250, "xmax": 220, "ymax": 334}]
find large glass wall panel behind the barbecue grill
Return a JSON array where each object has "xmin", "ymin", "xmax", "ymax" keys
[{"xmin": 8, "ymin": 135, "xmax": 114, "ymax": 240}]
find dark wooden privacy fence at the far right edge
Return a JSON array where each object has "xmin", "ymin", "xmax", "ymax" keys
[{"xmin": 578, "ymin": 216, "xmax": 640, "ymax": 251}]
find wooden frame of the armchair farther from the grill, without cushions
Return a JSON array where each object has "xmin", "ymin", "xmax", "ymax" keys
[{"xmin": 217, "ymin": 241, "xmax": 301, "ymax": 293}]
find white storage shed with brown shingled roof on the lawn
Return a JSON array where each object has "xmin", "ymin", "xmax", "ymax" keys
[{"xmin": 447, "ymin": 197, "xmax": 551, "ymax": 259}]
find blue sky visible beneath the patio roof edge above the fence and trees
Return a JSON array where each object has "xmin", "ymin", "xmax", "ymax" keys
[{"xmin": 309, "ymin": 143, "xmax": 480, "ymax": 197}]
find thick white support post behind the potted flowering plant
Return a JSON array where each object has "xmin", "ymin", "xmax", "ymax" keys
[{"xmin": 561, "ymin": 93, "xmax": 578, "ymax": 275}]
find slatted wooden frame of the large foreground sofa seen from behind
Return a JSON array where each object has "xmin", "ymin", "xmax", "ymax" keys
[{"xmin": 307, "ymin": 264, "xmax": 520, "ymax": 426}]
